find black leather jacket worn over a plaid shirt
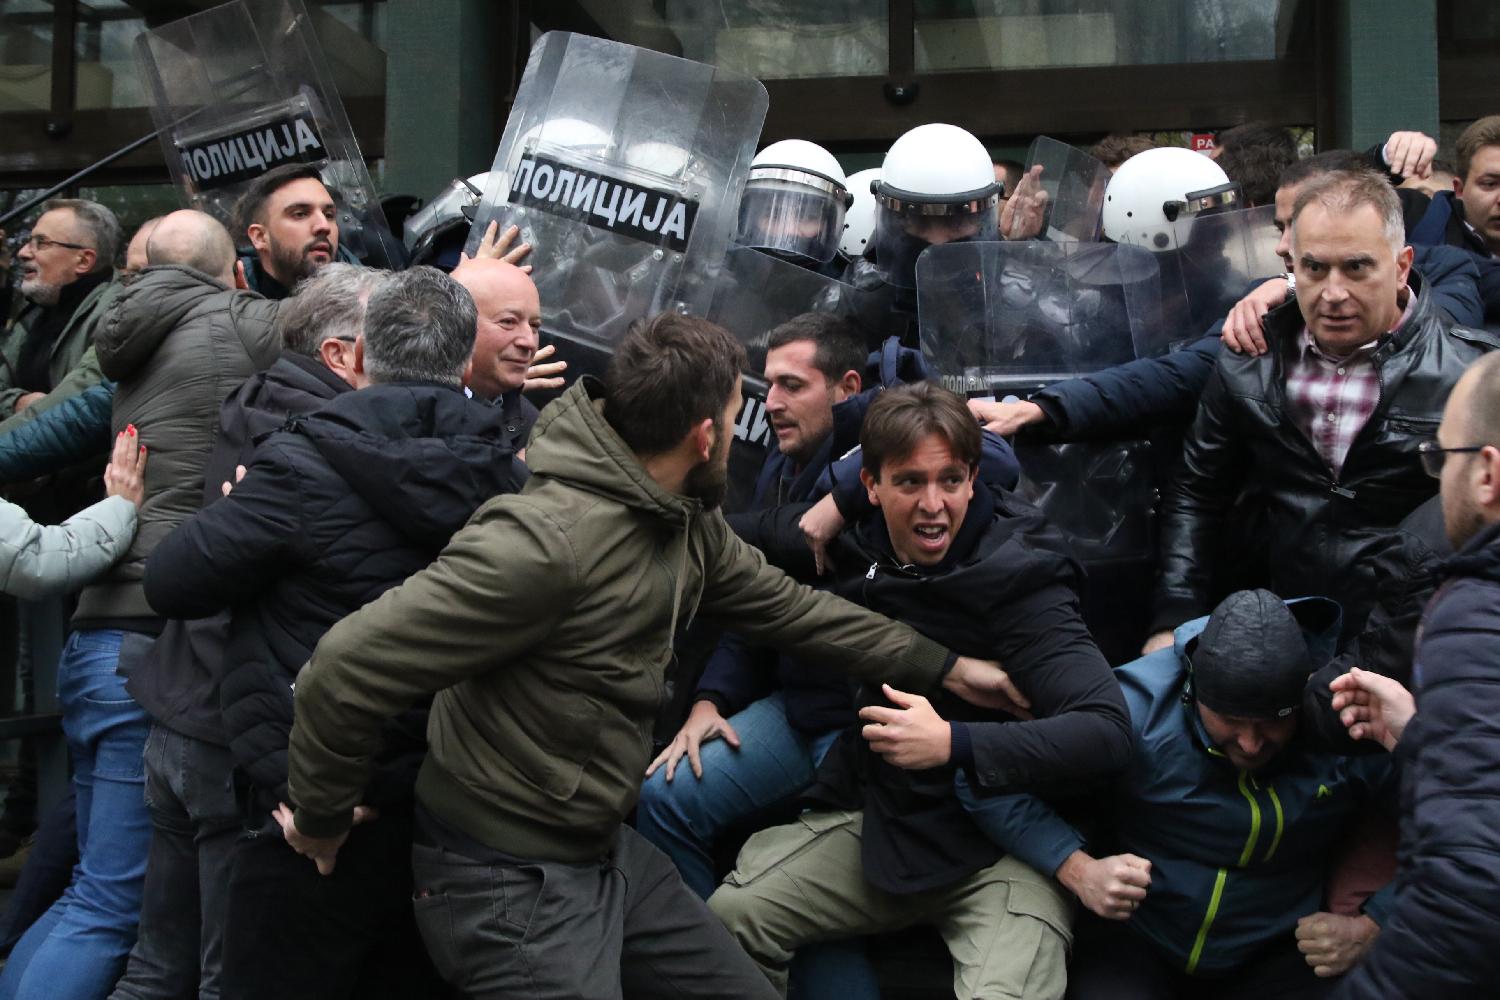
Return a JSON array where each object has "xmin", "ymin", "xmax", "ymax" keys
[{"xmin": 1152, "ymin": 284, "xmax": 1500, "ymax": 640}]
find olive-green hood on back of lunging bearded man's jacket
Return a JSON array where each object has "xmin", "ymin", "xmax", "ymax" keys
[{"xmin": 527, "ymin": 375, "xmax": 702, "ymax": 526}]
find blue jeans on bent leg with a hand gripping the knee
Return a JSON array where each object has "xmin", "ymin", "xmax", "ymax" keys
[{"xmin": 636, "ymin": 691, "xmax": 879, "ymax": 1000}]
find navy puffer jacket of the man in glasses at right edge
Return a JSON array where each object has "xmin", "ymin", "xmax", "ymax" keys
[{"xmin": 1337, "ymin": 525, "xmax": 1500, "ymax": 1000}]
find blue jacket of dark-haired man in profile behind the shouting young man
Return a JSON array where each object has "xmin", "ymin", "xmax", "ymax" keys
[{"xmin": 695, "ymin": 337, "xmax": 1020, "ymax": 733}]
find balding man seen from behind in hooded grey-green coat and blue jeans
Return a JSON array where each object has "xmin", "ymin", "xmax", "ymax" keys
[{"xmin": 0, "ymin": 211, "xmax": 281, "ymax": 997}]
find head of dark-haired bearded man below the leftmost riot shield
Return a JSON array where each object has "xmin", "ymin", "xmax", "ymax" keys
[{"xmin": 234, "ymin": 163, "xmax": 339, "ymax": 298}]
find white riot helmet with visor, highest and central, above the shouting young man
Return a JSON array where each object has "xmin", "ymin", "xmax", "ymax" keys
[{"xmin": 875, "ymin": 123, "xmax": 1001, "ymax": 288}]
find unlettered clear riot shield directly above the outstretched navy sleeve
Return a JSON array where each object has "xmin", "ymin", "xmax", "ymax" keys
[{"xmin": 917, "ymin": 241, "xmax": 1161, "ymax": 396}]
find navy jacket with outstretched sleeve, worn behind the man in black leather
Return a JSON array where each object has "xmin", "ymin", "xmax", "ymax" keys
[{"xmin": 1031, "ymin": 254, "xmax": 1485, "ymax": 441}]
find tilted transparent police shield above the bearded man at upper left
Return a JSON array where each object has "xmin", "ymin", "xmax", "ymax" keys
[{"xmin": 135, "ymin": 0, "xmax": 401, "ymax": 267}]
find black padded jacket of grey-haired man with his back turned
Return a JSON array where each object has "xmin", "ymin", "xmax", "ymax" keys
[{"xmin": 146, "ymin": 384, "xmax": 525, "ymax": 826}]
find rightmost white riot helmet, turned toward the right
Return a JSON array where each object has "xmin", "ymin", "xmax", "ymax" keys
[{"xmin": 1103, "ymin": 145, "xmax": 1241, "ymax": 253}]
